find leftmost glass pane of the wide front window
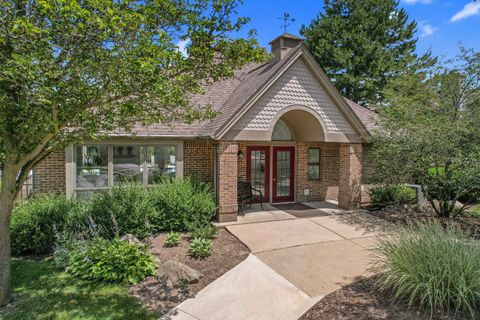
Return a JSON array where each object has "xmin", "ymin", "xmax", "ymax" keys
[{"xmin": 76, "ymin": 146, "xmax": 108, "ymax": 188}]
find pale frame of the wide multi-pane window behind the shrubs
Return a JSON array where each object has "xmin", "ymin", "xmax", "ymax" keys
[{"xmin": 71, "ymin": 141, "xmax": 183, "ymax": 197}]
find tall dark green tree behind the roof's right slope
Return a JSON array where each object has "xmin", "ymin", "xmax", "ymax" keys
[{"xmin": 300, "ymin": 0, "xmax": 432, "ymax": 105}]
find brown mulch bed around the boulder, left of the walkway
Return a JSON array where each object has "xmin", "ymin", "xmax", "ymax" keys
[{"xmin": 130, "ymin": 228, "xmax": 250, "ymax": 314}]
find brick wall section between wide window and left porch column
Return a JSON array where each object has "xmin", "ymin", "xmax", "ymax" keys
[{"xmin": 183, "ymin": 140, "xmax": 215, "ymax": 183}]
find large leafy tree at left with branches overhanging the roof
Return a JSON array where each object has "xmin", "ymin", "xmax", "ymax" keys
[{"xmin": 0, "ymin": 0, "xmax": 265, "ymax": 305}]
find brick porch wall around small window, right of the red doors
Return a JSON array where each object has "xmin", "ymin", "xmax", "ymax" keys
[{"xmin": 296, "ymin": 143, "xmax": 339, "ymax": 201}]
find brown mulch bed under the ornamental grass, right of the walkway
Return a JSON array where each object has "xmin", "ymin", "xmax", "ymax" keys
[{"xmin": 300, "ymin": 278, "xmax": 471, "ymax": 320}]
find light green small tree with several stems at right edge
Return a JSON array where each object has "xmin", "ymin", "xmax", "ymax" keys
[{"xmin": 373, "ymin": 48, "xmax": 480, "ymax": 217}]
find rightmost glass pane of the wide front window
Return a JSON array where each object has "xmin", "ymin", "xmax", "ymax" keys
[{"xmin": 146, "ymin": 146, "xmax": 177, "ymax": 184}]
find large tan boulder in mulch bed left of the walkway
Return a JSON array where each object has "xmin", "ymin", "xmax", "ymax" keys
[{"xmin": 157, "ymin": 260, "xmax": 203, "ymax": 286}]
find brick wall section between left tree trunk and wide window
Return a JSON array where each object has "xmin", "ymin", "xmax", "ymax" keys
[{"xmin": 33, "ymin": 151, "xmax": 66, "ymax": 194}]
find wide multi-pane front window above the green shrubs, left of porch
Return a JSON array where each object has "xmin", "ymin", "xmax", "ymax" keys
[{"xmin": 75, "ymin": 144, "xmax": 178, "ymax": 198}]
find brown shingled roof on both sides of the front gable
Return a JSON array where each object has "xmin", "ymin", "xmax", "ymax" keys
[{"xmin": 126, "ymin": 39, "xmax": 376, "ymax": 138}]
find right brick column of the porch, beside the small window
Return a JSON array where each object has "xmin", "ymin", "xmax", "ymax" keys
[{"xmin": 338, "ymin": 143, "xmax": 362, "ymax": 210}]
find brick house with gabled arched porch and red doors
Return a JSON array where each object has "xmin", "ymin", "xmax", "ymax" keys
[{"xmin": 34, "ymin": 33, "xmax": 375, "ymax": 221}]
